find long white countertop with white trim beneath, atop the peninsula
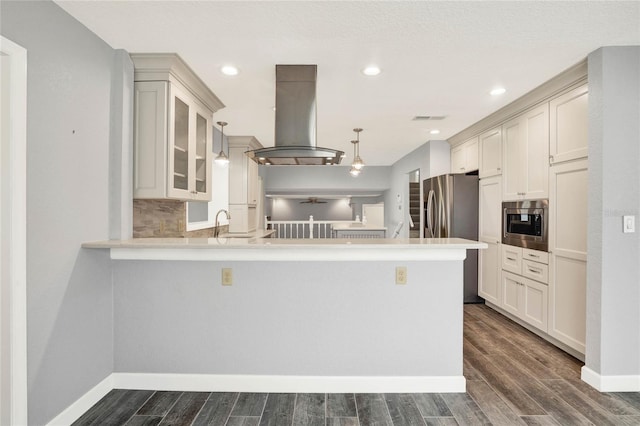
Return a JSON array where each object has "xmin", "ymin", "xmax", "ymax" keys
[{"xmin": 82, "ymin": 237, "xmax": 487, "ymax": 261}]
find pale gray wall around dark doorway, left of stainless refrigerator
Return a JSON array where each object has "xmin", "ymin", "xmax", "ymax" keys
[{"xmin": 384, "ymin": 141, "xmax": 450, "ymax": 238}]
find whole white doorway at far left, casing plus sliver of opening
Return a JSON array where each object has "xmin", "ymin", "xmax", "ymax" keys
[{"xmin": 0, "ymin": 36, "xmax": 27, "ymax": 424}]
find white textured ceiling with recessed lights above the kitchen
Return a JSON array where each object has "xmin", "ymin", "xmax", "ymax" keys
[{"xmin": 57, "ymin": 0, "xmax": 640, "ymax": 165}]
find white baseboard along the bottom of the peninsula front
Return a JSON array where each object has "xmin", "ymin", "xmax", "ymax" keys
[{"xmin": 112, "ymin": 373, "xmax": 466, "ymax": 393}]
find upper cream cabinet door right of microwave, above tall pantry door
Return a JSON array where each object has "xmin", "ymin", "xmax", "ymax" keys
[{"xmin": 549, "ymin": 85, "xmax": 589, "ymax": 164}]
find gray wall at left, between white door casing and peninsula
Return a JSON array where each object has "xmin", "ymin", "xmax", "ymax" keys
[{"xmin": 0, "ymin": 1, "xmax": 114, "ymax": 425}]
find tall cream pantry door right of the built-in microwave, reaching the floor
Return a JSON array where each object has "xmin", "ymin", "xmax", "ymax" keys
[{"xmin": 549, "ymin": 159, "xmax": 588, "ymax": 354}]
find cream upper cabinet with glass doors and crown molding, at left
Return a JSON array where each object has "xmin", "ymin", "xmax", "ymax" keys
[{"xmin": 131, "ymin": 53, "xmax": 224, "ymax": 201}]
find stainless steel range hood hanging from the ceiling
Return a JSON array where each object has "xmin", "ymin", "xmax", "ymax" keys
[{"xmin": 246, "ymin": 65, "xmax": 344, "ymax": 166}]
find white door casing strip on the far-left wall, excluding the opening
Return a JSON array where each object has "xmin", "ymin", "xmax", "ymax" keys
[{"xmin": 0, "ymin": 36, "xmax": 27, "ymax": 424}]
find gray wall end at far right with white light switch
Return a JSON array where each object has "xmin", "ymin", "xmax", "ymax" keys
[{"xmin": 586, "ymin": 46, "xmax": 640, "ymax": 376}]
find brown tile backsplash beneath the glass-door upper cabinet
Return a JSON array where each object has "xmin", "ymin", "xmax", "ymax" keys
[{"xmin": 133, "ymin": 200, "xmax": 227, "ymax": 238}]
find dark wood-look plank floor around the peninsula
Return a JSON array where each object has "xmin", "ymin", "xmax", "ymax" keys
[{"xmin": 74, "ymin": 305, "xmax": 640, "ymax": 426}]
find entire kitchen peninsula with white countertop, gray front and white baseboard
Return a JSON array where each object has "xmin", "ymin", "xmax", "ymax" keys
[{"xmin": 83, "ymin": 238, "xmax": 486, "ymax": 392}]
